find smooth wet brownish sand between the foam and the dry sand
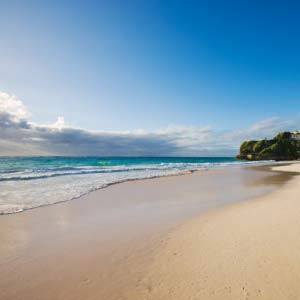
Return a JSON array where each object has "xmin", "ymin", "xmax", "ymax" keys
[{"xmin": 0, "ymin": 167, "xmax": 293, "ymax": 300}]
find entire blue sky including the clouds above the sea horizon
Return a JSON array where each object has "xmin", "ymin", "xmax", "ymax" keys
[{"xmin": 0, "ymin": 0, "xmax": 300, "ymax": 156}]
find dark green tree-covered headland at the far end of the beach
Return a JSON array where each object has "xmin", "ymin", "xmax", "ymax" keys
[{"xmin": 236, "ymin": 131, "xmax": 300, "ymax": 161}]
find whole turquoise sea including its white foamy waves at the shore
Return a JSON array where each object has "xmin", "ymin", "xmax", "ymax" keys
[{"xmin": 0, "ymin": 157, "xmax": 272, "ymax": 214}]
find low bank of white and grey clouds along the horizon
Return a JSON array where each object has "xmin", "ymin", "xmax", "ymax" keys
[{"xmin": 0, "ymin": 92, "xmax": 300, "ymax": 156}]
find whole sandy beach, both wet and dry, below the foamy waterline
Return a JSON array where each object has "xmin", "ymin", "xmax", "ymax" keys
[{"xmin": 0, "ymin": 168, "xmax": 300, "ymax": 300}]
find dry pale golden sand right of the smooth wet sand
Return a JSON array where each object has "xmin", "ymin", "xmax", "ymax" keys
[{"xmin": 127, "ymin": 163, "xmax": 300, "ymax": 300}]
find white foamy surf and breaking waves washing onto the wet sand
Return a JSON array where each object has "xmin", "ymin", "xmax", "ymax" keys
[{"xmin": 0, "ymin": 162, "xmax": 274, "ymax": 214}]
